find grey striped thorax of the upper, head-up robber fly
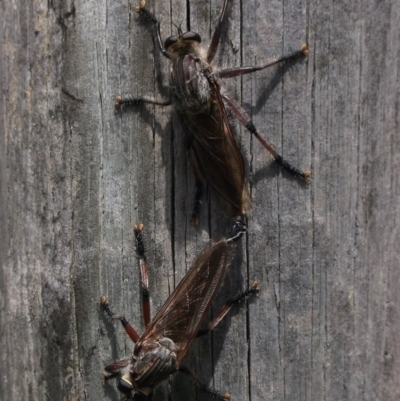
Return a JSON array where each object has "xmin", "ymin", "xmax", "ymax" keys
[{"xmin": 171, "ymin": 54, "xmax": 210, "ymax": 114}]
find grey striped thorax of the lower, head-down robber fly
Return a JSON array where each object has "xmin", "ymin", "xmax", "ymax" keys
[{"xmin": 130, "ymin": 337, "xmax": 178, "ymax": 387}]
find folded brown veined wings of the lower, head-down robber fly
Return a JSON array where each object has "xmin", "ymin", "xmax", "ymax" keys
[{"xmin": 135, "ymin": 241, "xmax": 236, "ymax": 363}]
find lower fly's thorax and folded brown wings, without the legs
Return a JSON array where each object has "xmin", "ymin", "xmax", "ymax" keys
[{"xmin": 129, "ymin": 241, "xmax": 236, "ymax": 388}]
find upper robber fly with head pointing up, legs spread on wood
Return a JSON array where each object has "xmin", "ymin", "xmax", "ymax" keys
[{"xmin": 116, "ymin": 0, "xmax": 310, "ymax": 225}]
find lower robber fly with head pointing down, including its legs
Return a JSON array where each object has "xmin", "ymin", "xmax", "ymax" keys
[{"xmin": 100, "ymin": 222, "xmax": 258, "ymax": 401}]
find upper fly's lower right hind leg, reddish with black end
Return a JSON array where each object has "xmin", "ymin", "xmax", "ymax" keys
[{"xmin": 222, "ymin": 95, "xmax": 311, "ymax": 182}]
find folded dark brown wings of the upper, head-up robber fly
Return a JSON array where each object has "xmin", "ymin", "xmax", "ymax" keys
[{"xmin": 178, "ymin": 86, "xmax": 250, "ymax": 217}]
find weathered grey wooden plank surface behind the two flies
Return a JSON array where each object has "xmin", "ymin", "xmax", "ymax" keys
[{"xmin": 0, "ymin": 0, "xmax": 400, "ymax": 401}]
